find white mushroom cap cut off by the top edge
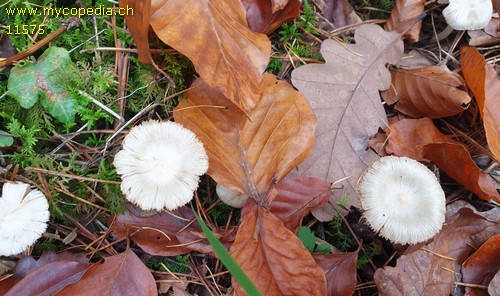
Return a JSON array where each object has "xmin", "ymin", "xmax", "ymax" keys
[{"xmin": 443, "ymin": 0, "xmax": 493, "ymax": 30}]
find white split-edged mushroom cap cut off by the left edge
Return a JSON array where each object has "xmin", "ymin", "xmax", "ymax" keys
[{"xmin": 0, "ymin": 182, "xmax": 50, "ymax": 256}]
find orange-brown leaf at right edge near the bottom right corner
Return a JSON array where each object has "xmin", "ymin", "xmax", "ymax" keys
[{"xmin": 462, "ymin": 234, "xmax": 500, "ymax": 295}]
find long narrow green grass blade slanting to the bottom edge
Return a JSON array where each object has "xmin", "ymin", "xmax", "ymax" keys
[{"xmin": 193, "ymin": 211, "xmax": 262, "ymax": 296}]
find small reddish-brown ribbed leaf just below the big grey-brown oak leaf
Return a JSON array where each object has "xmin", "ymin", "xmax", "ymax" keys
[{"xmin": 271, "ymin": 176, "xmax": 331, "ymax": 233}]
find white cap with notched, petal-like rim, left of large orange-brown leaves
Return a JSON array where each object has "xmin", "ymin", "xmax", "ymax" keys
[{"xmin": 114, "ymin": 120, "xmax": 208, "ymax": 210}]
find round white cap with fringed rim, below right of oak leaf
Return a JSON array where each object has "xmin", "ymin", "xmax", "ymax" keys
[{"xmin": 358, "ymin": 156, "xmax": 446, "ymax": 244}]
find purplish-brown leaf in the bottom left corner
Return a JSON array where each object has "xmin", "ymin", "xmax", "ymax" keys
[{"xmin": 0, "ymin": 252, "xmax": 92, "ymax": 296}]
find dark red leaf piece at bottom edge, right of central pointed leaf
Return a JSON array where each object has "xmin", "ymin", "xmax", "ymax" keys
[{"xmin": 313, "ymin": 250, "xmax": 359, "ymax": 296}]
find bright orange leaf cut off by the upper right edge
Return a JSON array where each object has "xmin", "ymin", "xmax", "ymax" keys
[{"xmin": 460, "ymin": 46, "xmax": 500, "ymax": 159}]
